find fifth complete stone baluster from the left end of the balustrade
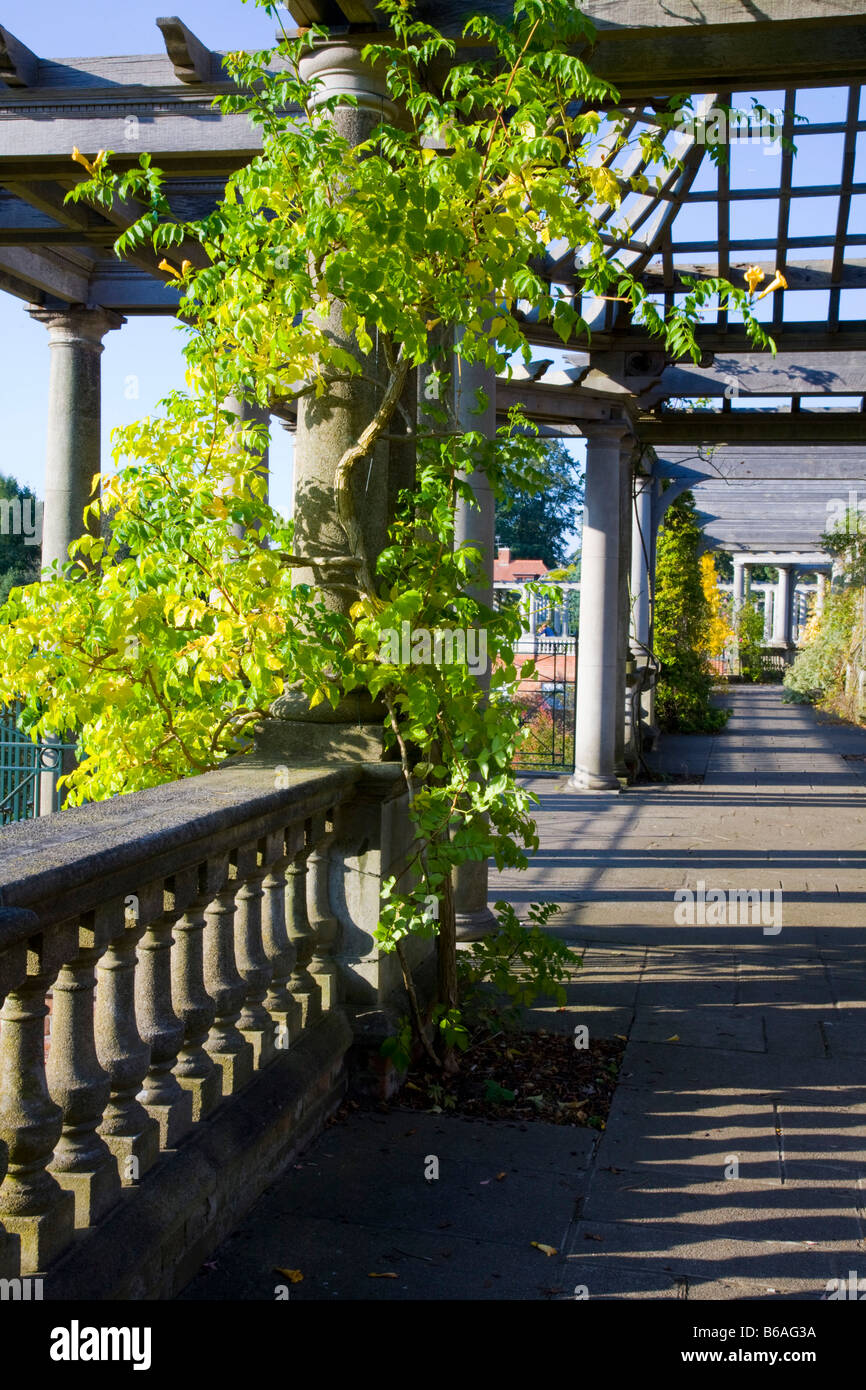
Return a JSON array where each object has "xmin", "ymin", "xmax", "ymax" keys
[{"xmin": 167, "ymin": 858, "xmax": 227, "ymax": 1123}]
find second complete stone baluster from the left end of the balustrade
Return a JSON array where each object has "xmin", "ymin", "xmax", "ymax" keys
[{"xmin": 47, "ymin": 913, "xmax": 121, "ymax": 1227}]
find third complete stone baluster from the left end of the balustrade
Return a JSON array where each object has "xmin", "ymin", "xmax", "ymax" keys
[{"xmin": 96, "ymin": 895, "xmax": 160, "ymax": 1187}]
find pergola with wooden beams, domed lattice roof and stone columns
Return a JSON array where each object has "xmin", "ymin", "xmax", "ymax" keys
[{"xmin": 0, "ymin": 0, "xmax": 866, "ymax": 806}]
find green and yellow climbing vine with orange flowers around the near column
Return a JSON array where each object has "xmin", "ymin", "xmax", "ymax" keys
[{"xmin": 0, "ymin": 0, "xmax": 769, "ymax": 1058}]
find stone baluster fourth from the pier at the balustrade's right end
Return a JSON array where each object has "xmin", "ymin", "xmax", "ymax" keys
[{"xmin": 232, "ymin": 840, "xmax": 277, "ymax": 1070}]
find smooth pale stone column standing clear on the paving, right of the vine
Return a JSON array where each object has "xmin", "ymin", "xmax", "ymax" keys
[{"xmin": 569, "ymin": 424, "xmax": 626, "ymax": 791}]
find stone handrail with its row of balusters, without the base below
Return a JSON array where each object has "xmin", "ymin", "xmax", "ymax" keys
[{"xmin": 0, "ymin": 765, "xmax": 369, "ymax": 1279}]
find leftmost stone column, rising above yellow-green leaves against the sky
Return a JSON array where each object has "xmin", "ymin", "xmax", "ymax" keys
[{"xmin": 29, "ymin": 307, "xmax": 125, "ymax": 567}]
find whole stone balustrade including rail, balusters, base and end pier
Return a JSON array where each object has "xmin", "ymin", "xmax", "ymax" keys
[{"xmin": 0, "ymin": 763, "xmax": 422, "ymax": 1298}]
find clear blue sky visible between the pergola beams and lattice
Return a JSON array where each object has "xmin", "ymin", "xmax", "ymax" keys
[{"xmin": 0, "ymin": 0, "xmax": 866, "ymax": 522}]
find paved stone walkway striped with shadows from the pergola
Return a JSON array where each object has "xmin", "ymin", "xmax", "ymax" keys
[{"xmin": 182, "ymin": 687, "xmax": 866, "ymax": 1300}]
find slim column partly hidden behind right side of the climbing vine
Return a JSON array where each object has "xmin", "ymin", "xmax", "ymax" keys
[{"xmin": 453, "ymin": 356, "xmax": 497, "ymax": 941}]
